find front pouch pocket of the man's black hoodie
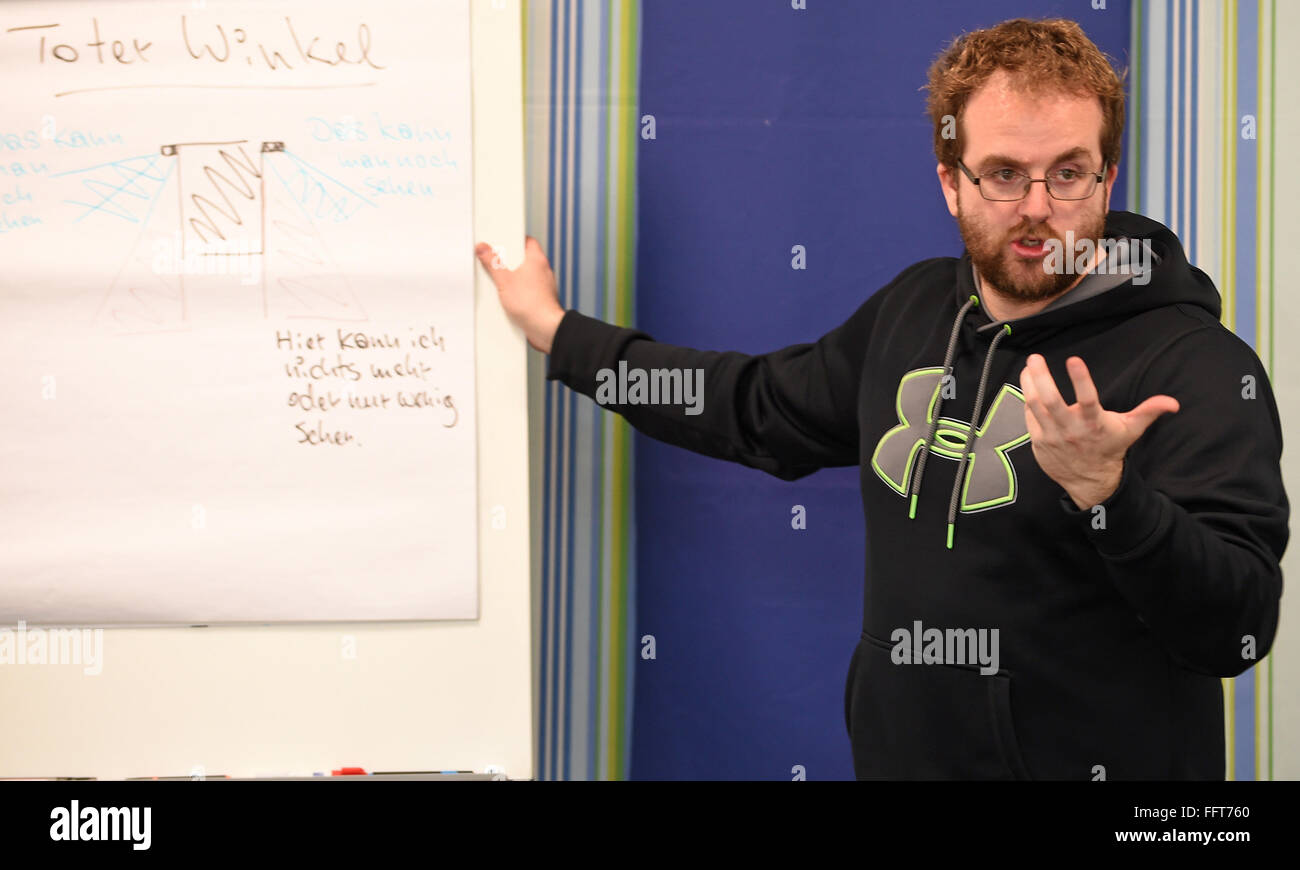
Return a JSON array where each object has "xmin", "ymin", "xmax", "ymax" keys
[{"xmin": 844, "ymin": 633, "xmax": 1030, "ymax": 779}]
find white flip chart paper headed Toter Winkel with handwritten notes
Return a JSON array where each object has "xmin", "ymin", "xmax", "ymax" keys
[{"xmin": 0, "ymin": 0, "xmax": 477, "ymax": 624}]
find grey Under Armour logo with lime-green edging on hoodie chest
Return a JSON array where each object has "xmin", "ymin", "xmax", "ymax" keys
[{"xmin": 871, "ymin": 368, "xmax": 1030, "ymax": 514}]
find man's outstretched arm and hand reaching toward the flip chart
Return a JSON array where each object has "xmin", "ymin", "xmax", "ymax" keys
[{"xmin": 476, "ymin": 237, "xmax": 880, "ymax": 480}]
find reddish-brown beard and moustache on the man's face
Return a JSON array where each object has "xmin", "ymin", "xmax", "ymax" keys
[{"xmin": 957, "ymin": 189, "xmax": 1106, "ymax": 302}]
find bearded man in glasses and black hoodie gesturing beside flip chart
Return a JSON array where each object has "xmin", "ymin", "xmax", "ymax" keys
[{"xmin": 478, "ymin": 20, "xmax": 1290, "ymax": 779}]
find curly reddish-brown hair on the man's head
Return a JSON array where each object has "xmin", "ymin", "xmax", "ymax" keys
[{"xmin": 924, "ymin": 18, "xmax": 1128, "ymax": 168}]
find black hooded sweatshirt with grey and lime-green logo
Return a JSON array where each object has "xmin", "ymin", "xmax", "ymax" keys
[{"xmin": 547, "ymin": 212, "xmax": 1290, "ymax": 779}]
